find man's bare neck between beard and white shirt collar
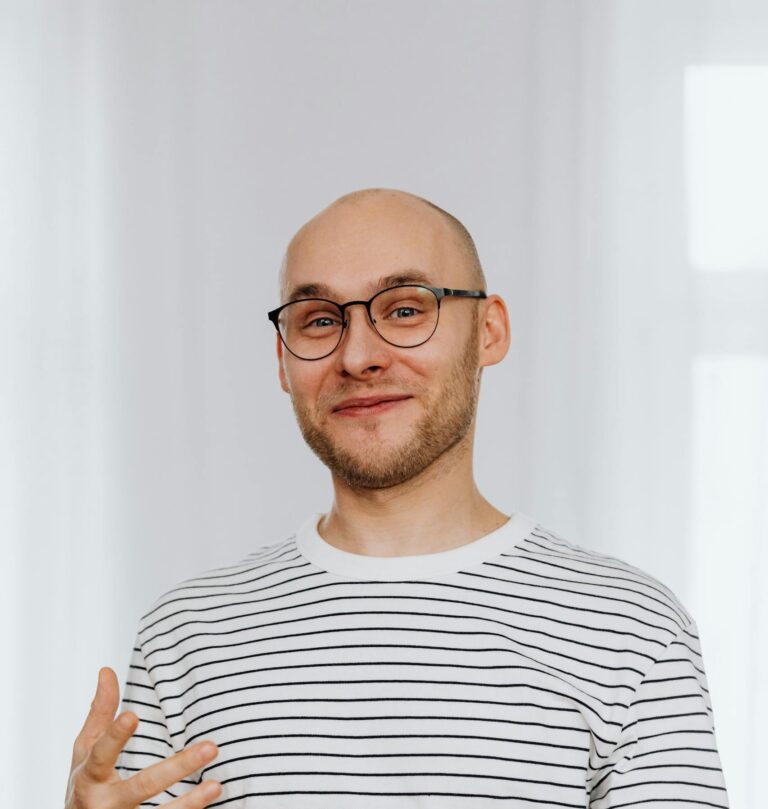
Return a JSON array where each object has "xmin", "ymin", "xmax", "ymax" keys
[{"xmin": 318, "ymin": 434, "xmax": 509, "ymax": 556}]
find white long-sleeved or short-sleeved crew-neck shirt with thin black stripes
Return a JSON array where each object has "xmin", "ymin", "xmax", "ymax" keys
[{"xmin": 117, "ymin": 512, "xmax": 728, "ymax": 809}]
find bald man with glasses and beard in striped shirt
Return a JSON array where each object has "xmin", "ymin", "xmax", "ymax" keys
[{"xmin": 68, "ymin": 189, "xmax": 728, "ymax": 809}]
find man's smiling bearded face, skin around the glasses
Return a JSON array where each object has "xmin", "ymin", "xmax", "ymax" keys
[{"xmin": 277, "ymin": 197, "xmax": 492, "ymax": 489}]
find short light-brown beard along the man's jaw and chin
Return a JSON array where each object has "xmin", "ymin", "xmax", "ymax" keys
[{"xmin": 291, "ymin": 328, "xmax": 480, "ymax": 489}]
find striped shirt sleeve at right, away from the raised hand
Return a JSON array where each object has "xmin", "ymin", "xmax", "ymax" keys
[{"xmin": 589, "ymin": 622, "xmax": 728, "ymax": 809}]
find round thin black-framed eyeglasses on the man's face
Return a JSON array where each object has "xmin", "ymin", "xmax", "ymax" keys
[{"xmin": 267, "ymin": 284, "xmax": 487, "ymax": 360}]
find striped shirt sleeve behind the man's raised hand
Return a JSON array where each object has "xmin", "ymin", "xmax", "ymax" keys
[{"xmin": 115, "ymin": 635, "xmax": 201, "ymax": 806}]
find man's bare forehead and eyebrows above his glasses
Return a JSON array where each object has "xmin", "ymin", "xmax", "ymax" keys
[{"xmin": 281, "ymin": 200, "xmax": 464, "ymax": 301}]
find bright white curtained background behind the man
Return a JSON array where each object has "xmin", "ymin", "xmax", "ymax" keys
[{"xmin": 0, "ymin": 0, "xmax": 768, "ymax": 809}]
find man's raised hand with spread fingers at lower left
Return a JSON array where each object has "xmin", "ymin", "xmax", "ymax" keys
[{"xmin": 64, "ymin": 666, "xmax": 221, "ymax": 809}]
